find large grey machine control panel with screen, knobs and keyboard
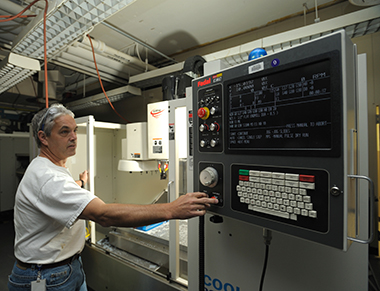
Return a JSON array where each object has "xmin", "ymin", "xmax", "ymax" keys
[{"xmin": 192, "ymin": 31, "xmax": 357, "ymax": 250}]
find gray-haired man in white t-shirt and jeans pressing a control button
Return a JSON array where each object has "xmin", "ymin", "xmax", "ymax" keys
[{"xmin": 8, "ymin": 104, "xmax": 217, "ymax": 291}]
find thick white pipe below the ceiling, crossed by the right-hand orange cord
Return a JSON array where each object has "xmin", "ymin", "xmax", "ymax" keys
[{"xmin": 78, "ymin": 37, "xmax": 157, "ymax": 73}]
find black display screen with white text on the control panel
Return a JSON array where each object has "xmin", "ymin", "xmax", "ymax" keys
[{"xmin": 225, "ymin": 58, "xmax": 333, "ymax": 152}]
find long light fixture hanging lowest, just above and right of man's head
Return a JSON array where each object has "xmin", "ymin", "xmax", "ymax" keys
[{"xmin": 66, "ymin": 85, "xmax": 141, "ymax": 110}]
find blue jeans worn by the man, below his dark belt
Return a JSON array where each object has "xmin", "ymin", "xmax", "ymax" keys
[{"xmin": 8, "ymin": 257, "xmax": 87, "ymax": 291}]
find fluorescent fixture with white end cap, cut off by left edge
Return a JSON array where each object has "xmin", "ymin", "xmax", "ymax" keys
[{"xmin": 0, "ymin": 53, "xmax": 40, "ymax": 93}]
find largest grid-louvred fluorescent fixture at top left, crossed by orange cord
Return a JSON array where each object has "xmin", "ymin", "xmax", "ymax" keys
[{"xmin": 12, "ymin": 0, "xmax": 135, "ymax": 59}]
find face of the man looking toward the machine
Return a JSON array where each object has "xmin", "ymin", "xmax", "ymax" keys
[{"xmin": 46, "ymin": 115, "xmax": 78, "ymax": 160}]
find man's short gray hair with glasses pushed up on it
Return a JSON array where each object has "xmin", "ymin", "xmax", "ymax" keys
[{"xmin": 32, "ymin": 103, "xmax": 74, "ymax": 147}]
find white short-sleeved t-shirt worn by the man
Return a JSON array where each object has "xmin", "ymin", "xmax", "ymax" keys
[{"xmin": 14, "ymin": 157, "xmax": 95, "ymax": 264}]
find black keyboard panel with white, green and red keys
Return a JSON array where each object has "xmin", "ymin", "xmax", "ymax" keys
[{"xmin": 231, "ymin": 165, "xmax": 329, "ymax": 232}]
